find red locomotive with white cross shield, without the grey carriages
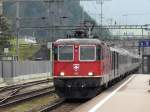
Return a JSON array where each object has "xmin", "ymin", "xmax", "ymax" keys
[{"xmin": 53, "ymin": 39, "xmax": 112, "ymax": 99}]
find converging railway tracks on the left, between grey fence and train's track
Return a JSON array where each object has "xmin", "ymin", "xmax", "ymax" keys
[{"xmin": 0, "ymin": 80, "xmax": 55, "ymax": 108}]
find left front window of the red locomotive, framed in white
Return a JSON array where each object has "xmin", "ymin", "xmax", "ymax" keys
[{"xmin": 58, "ymin": 45, "xmax": 73, "ymax": 61}]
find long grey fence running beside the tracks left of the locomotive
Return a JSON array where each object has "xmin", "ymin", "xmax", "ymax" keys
[{"xmin": 0, "ymin": 61, "xmax": 52, "ymax": 79}]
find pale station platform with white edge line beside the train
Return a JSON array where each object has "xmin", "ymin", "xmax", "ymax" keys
[{"xmin": 72, "ymin": 74, "xmax": 150, "ymax": 112}]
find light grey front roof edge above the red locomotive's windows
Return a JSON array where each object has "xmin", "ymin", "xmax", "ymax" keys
[{"xmin": 55, "ymin": 39, "xmax": 102, "ymax": 44}]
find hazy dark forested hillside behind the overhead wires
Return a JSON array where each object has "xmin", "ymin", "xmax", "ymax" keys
[{"xmin": 4, "ymin": 0, "xmax": 108, "ymax": 40}]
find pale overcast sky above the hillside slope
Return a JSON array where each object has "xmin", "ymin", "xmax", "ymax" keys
[{"xmin": 81, "ymin": 0, "xmax": 150, "ymax": 24}]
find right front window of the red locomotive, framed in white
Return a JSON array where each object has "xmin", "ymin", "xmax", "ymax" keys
[{"xmin": 79, "ymin": 45, "xmax": 96, "ymax": 61}]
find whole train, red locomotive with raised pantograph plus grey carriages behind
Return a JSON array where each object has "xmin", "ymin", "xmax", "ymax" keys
[{"xmin": 53, "ymin": 21, "xmax": 141, "ymax": 99}]
